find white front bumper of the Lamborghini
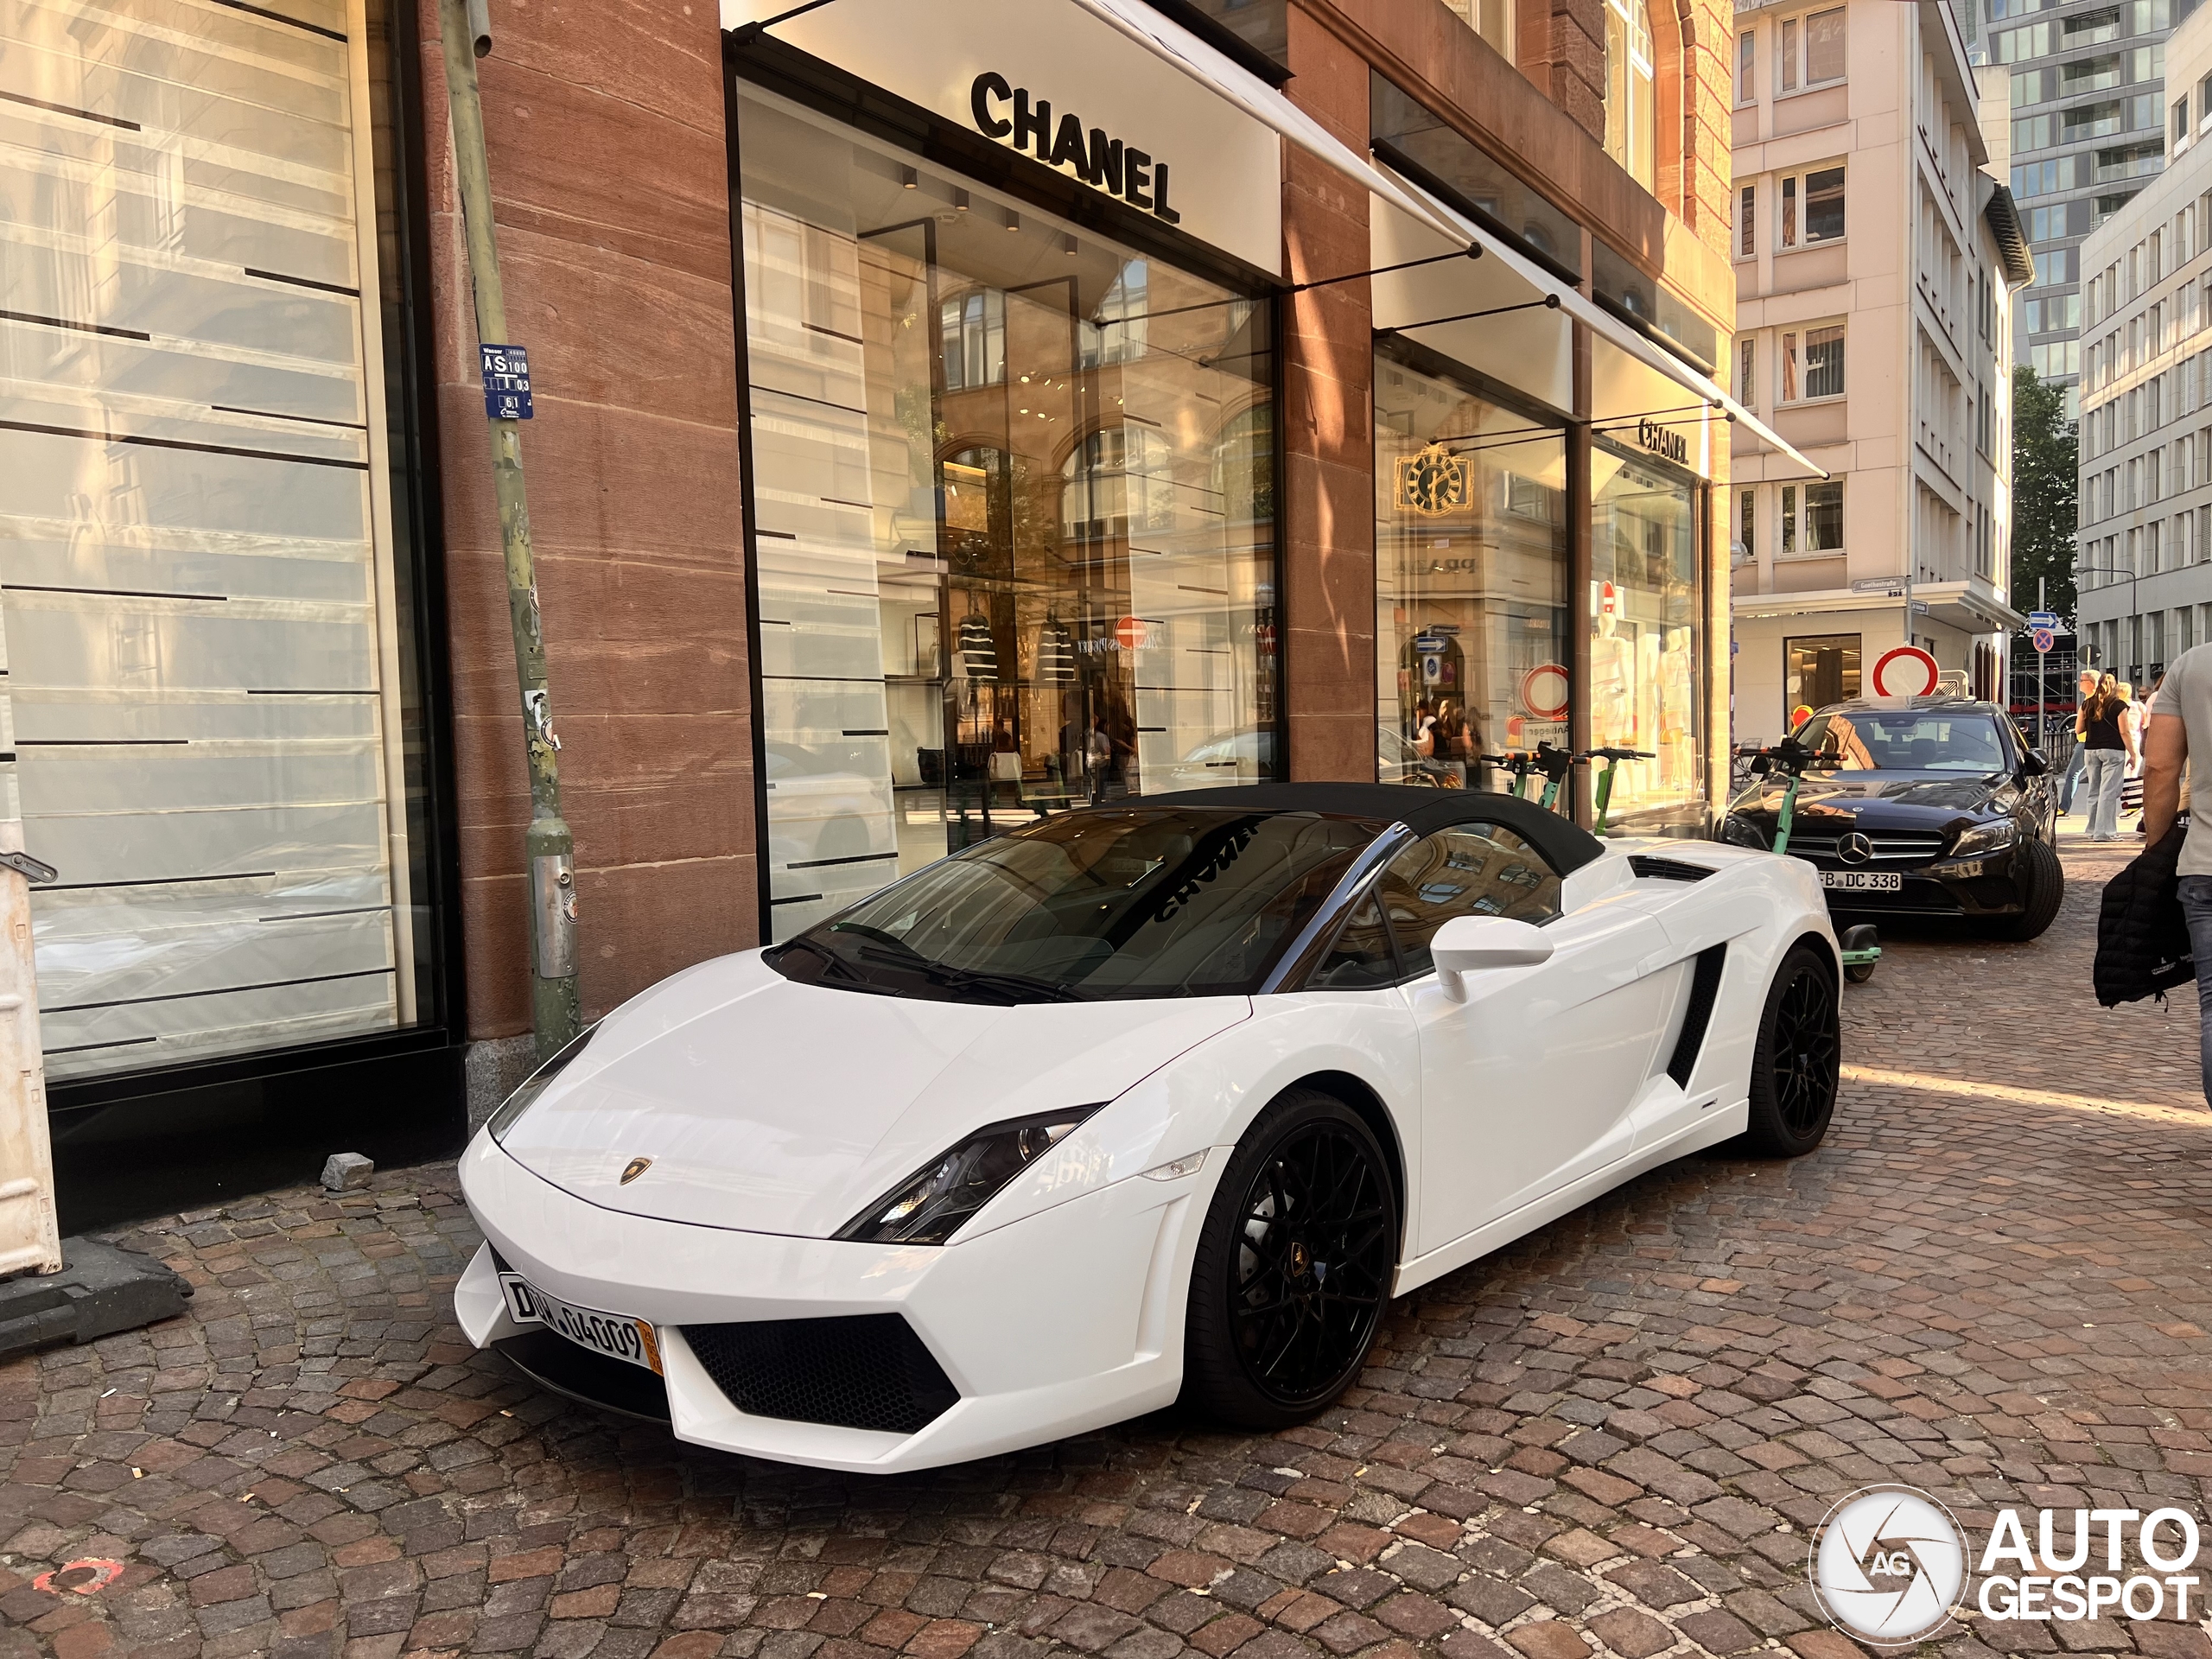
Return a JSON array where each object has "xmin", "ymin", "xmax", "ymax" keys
[{"xmin": 454, "ymin": 1135, "xmax": 1219, "ymax": 1473}]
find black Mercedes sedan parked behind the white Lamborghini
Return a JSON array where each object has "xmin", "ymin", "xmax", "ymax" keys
[{"xmin": 1721, "ymin": 696, "xmax": 2066, "ymax": 940}]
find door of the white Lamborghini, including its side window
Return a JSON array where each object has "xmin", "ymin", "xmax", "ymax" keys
[{"xmin": 1376, "ymin": 823, "xmax": 1676, "ymax": 1255}]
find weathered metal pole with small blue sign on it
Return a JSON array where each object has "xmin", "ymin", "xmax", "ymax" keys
[{"xmin": 438, "ymin": 0, "xmax": 580, "ymax": 1059}]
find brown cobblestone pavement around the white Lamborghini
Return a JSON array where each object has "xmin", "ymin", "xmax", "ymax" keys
[{"xmin": 0, "ymin": 849, "xmax": 2212, "ymax": 1659}]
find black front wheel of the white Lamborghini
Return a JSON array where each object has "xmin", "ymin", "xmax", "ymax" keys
[{"xmin": 1184, "ymin": 1089, "xmax": 1398, "ymax": 1429}]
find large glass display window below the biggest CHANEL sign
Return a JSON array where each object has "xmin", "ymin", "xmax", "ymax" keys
[{"xmin": 739, "ymin": 86, "xmax": 1281, "ymax": 940}]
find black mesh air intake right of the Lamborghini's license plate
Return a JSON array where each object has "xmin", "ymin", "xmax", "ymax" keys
[{"xmin": 683, "ymin": 1314, "xmax": 960, "ymax": 1433}]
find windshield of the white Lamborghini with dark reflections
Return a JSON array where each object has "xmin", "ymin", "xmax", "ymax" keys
[{"xmin": 767, "ymin": 805, "xmax": 1382, "ymax": 1002}]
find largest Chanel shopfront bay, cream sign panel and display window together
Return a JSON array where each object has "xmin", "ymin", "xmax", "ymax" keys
[{"xmin": 730, "ymin": 0, "xmax": 1283, "ymax": 938}]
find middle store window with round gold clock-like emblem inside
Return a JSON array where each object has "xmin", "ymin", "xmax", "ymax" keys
[{"xmin": 1374, "ymin": 354, "xmax": 1571, "ymax": 790}]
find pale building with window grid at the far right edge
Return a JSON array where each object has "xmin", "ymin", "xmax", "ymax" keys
[{"xmin": 2075, "ymin": 9, "xmax": 2212, "ymax": 686}]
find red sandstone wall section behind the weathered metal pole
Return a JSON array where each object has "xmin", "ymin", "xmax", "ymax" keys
[{"xmin": 418, "ymin": 0, "xmax": 757, "ymax": 1038}]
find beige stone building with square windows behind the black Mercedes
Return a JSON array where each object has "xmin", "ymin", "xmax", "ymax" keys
[{"xmin": 1730, "ymin": 0, "xmax": 2033, "ymax": 743}]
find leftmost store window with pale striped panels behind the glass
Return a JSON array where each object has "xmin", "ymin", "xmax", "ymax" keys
[{"xmin": 0, "ymin": 0, "xmax": 440, "ymax": 1082}]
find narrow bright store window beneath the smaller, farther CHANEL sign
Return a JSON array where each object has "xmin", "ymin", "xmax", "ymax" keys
[{"xmin": 1591, "ymin": 442, "xmax": 1707, "ymax": 834}]
